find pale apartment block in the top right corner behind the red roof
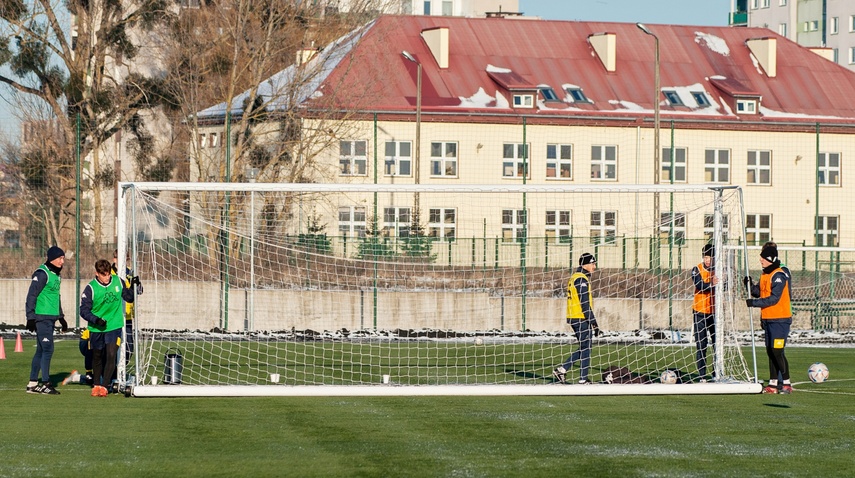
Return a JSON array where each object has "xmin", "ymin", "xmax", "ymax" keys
[{"xmin": 730, "ymin": 0, "xmax": 855, "ymax": 70}]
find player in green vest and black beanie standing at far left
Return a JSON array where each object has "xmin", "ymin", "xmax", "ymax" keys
[{"xmin": 25, "ymin": 246, "xmax": 68, "ymax": 395}]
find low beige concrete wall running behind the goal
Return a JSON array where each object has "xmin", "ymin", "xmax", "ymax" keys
[{"xmin": 0, "ymin": 280, "xmax": 810, "ymax": 332}]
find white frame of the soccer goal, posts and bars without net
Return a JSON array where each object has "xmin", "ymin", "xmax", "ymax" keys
[{"xmin": 117, "ymin": 182, "xmax": 762, "ymax": 397}]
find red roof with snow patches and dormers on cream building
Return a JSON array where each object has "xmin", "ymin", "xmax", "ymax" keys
[{"xmin": 312, "ymin": 16, "xmax": 855, "ymax": 122}]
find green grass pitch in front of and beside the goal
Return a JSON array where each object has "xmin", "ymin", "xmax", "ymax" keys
[{"xmin": 0, "ymin": 338, "xmax": 855, "ymax": 477}]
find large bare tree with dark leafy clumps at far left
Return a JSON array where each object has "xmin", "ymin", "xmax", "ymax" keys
[{"xmin": 0, "ymin": 0, "xmax": 175, "ymax": 243}]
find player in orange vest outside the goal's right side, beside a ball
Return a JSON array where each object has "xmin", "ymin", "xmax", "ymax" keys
[{"xmin": 743, "ymin": 242, "xmax": 793, "ymax": 394}]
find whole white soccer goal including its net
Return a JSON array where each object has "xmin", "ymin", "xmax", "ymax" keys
[{"xmin": 118, "ymin": 183, "xmax": 760, "ymax": 396}]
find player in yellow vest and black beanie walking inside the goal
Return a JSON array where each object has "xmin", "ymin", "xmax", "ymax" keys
[{"xmin": 552, "ymin": 252, "xmax": 600, "ymax": 384}]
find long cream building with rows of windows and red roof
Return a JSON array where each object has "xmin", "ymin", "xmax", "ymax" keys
[{"xmin": 191, "ymin": 16, "xmax": 855, "ymax": 258}]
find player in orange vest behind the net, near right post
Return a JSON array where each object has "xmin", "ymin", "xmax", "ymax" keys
[{"xmin": 692, "ymin": 244, "xmax": 718, "ymax": 382}]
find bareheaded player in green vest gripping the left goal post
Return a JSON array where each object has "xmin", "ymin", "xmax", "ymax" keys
[{"xmin": 80, "ymin": 259, "xmax": 134, "ymax": 397}]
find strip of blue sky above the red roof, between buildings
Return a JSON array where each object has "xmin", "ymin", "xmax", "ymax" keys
[{"xmin": 519, "ymin": 0, "xmax": 730, "ymax": 26}]
